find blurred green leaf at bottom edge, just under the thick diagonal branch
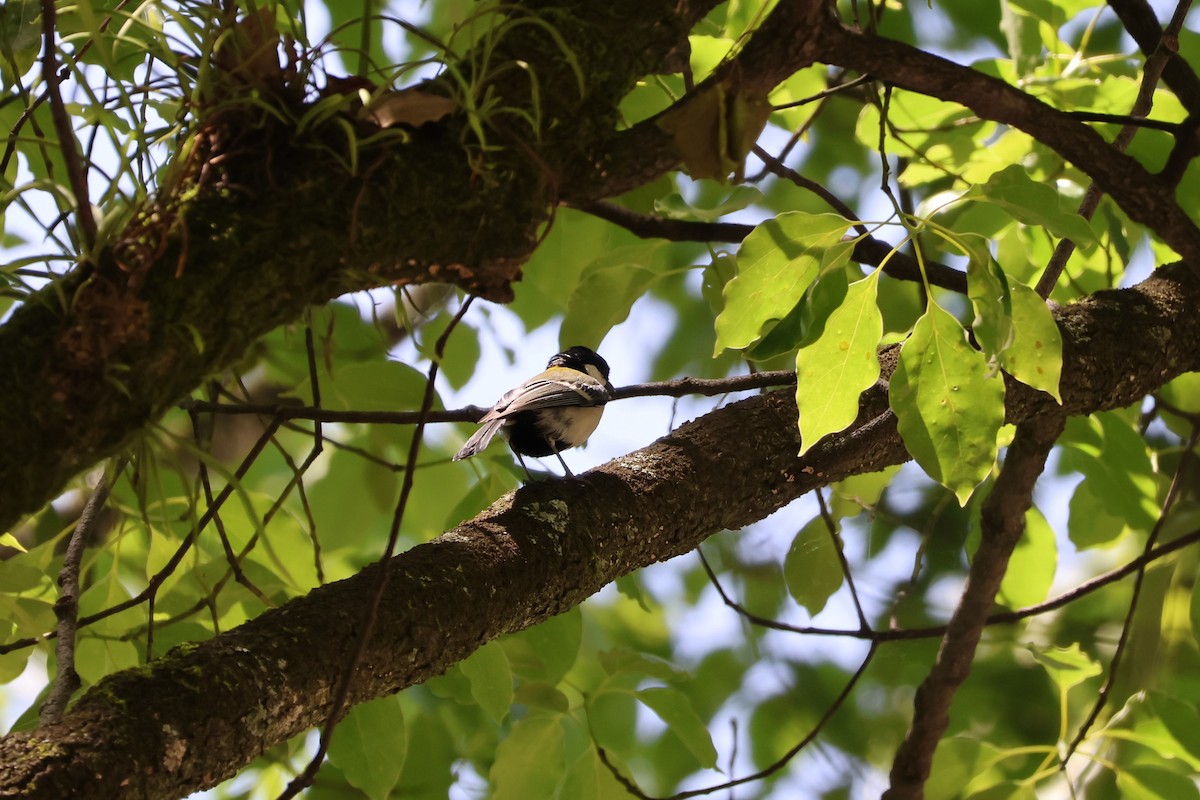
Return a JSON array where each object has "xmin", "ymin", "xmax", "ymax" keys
[{"xmin": 329, "ymin": 696, "xmax": 408, "ymax": 800}]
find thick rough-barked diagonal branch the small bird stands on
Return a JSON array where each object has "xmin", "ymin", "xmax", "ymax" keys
[{"xmin": 0, "ymin": 265, "xmax": 1200, "ymax": 800}]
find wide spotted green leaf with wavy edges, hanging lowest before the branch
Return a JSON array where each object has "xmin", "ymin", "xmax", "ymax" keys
[{"xmin": 889, "ymin": 303, "xmax": 1004, "ymax": 504}]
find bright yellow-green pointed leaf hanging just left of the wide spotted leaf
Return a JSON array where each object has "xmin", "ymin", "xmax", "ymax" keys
[{"xmin": 796, "ymin": 271, "xmax": 883, "ymax": 455}]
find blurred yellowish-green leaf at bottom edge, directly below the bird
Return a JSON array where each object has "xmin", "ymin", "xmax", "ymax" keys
[{"xmin": 488, "ymin": 714, "xmax": 566, "ymax": 800}]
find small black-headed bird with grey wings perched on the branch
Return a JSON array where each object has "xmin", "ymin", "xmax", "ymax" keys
[{"xmin": 454, "ymin": 347, "xmax": 612, "ymax": 477}]
